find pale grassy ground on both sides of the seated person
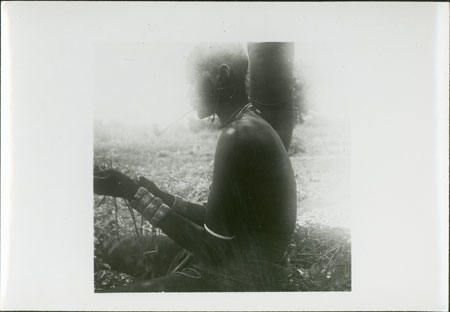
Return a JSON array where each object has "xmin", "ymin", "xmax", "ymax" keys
[{"xmin": 94, "ymin": 117, "xmax": 351, "ymax": 291}]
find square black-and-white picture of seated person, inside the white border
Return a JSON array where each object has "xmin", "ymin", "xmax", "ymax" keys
[{"xmin": 93, "ymin": 42, "xmax": 352, "ymax": 292}]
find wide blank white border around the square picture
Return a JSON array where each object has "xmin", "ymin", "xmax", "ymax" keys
[{"xmin": 0, "ymin": 2, "xmax": 449, "ymax": 311}]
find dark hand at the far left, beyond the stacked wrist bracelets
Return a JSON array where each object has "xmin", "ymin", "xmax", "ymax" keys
[{"xmin": 94, "ymin": 168, "xmax": 139, "ymax": 200}]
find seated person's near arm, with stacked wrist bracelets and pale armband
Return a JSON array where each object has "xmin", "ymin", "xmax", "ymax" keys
[{"xmin": 132, "ymin": 131, "xmax": 248, "ymax": 263}]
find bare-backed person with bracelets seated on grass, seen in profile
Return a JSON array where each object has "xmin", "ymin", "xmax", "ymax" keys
[{"xmin": 94, "ymin": 44, "xmax": 297, "ymax": 292}]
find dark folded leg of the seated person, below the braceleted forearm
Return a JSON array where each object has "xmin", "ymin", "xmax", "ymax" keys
[{"xmin": 96, "ymin": 236, "xmax": 220, "ymax": 293}]
